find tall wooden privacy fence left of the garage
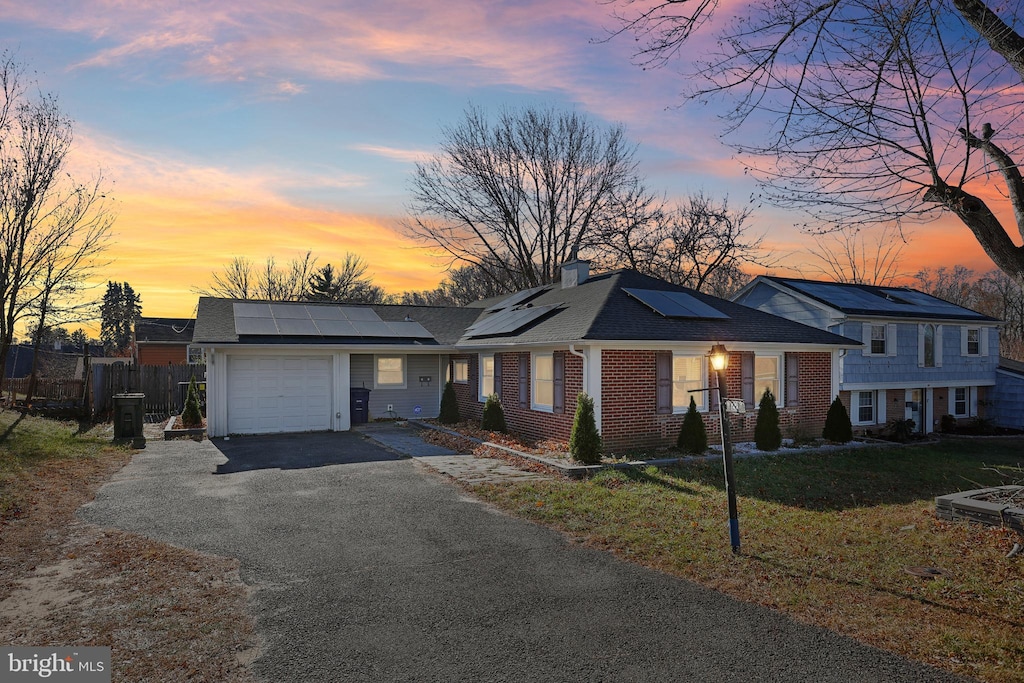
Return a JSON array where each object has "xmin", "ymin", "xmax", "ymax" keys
[{"xmin": 90, "ymin": 364, "xmax": 206, "ymax": 416}]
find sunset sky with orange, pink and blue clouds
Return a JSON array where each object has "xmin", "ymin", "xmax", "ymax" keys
[{"xmin": 0, "ymin": 0, "xmax": 992, "ymax": 323}]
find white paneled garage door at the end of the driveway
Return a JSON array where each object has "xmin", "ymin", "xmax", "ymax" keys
[{"xmin": 227, "ymin": 355, "xmax": 332, "ymax": 434}]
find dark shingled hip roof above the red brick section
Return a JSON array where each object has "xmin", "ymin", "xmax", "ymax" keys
[{"xmin": 459, "ymin": 270, "xmax": 860, "ymax": 346}]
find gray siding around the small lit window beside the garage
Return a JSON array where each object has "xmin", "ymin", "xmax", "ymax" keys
[{"xmin": 351, "ymin": 353, "xmax": 444, "ymax": 420}]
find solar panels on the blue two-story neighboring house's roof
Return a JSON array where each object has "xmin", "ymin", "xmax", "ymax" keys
[{"xmin": 785, "ymin": 280, "xmax": 985, "ymax": 318}]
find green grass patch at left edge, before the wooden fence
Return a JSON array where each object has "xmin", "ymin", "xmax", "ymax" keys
[{"xmin": 0, "ymin": 411, "xmax": 119, "ymax": 519}]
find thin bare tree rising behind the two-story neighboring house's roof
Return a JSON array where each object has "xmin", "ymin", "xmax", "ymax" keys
[{"xmin": 807, "ymin": 225, "xmax": 907, "ymax": 286}]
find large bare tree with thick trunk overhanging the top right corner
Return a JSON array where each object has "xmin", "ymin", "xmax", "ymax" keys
[{"xmin": 611, "ymin": 0, "xmax": 1024, "ymax": 284}]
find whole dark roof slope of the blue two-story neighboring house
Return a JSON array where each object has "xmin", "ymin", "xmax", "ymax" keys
[{"xmin": 762, "ymin": 275, "xmax": 996, "ymax": 323}]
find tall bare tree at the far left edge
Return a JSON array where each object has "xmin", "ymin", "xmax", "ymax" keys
[{"xmin": 0, "ymin": 51, "xmax": 114, "ymax": 379}]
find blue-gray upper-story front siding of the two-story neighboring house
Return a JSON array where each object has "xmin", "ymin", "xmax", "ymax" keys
[{"xmin": 842, "ymin": 322, "xmax": 999, "ymax": 386}]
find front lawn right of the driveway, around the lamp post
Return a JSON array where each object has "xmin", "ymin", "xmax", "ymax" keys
[{"xmin": 473, "ymin": 439, "xmax": 1024, "ymax": 681}]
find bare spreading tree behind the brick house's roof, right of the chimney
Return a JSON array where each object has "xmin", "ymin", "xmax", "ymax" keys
[{"xmin": 598, "ymin": 193, "xmax": 773, "ymax": 292}]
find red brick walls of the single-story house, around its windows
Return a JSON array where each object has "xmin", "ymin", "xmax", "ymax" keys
[{"xmin": 452, "ymin": 349, "xmax": 831, "ymax": 453}]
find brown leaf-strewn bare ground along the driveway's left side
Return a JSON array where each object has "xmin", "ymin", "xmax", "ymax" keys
[{"xmin": 0, "ymin": 430, "xmax": 258, "ymax": 683}]
